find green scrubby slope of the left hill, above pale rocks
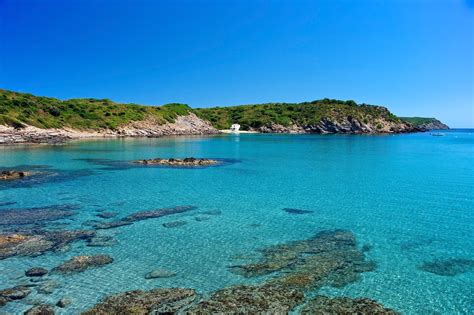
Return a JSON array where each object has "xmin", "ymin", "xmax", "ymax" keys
[{"xmin": 0, "ymin": 89, "xmax": 191, "ymax": 130}]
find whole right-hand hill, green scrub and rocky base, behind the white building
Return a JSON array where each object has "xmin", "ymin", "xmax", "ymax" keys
[{"xmin": 195, "ymin": 99, "xmax": 415, "ymax": 133}]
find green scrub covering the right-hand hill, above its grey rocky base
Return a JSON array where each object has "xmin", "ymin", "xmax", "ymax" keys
[{"xmin": 195, "ymin": 99, "xmax": 400, "ymax": 130}]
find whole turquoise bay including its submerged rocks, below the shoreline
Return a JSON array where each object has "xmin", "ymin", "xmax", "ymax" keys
[{"xmin": 0, "ymin": 129, "xmax": 474, "ymax": 314}]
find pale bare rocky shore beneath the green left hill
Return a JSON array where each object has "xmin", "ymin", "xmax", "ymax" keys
[{"xmin": 0, "ymin": 113, "xmax": 219, "ymax": 145}]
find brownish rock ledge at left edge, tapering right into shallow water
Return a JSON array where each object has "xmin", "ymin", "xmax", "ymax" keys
[{"xmin": 0, "ymin": 230, "xmax": 95, "ymax": 259}]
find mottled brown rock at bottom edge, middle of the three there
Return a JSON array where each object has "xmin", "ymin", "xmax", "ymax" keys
[{"xmin": 188, "ymin": 285, "xmax": 304, "ymax": 314}]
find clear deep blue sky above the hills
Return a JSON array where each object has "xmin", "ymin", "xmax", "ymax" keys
[{"xmin": 0, "ymin": 0, "xmax": 474, "ymax": 127}]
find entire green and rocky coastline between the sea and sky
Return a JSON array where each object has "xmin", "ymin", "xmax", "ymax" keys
[{"xmin": 0, "ymin": 89, "xmax": 448, "ymax": 144}]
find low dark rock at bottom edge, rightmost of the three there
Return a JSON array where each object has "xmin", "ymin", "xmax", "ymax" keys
[{"xmin": 301, "ymin": 295, "xmax": 398, "ymax": 315}]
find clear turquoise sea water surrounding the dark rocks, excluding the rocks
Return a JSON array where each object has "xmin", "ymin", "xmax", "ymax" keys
[{"xmin": 0, "ymin": 130, "xmax": 474, "ymax": 314}]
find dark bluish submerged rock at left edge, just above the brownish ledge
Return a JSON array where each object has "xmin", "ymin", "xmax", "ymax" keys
[{"xmin": 0, "ymin": 205, "xmax": 78, "ymax": 225}]
